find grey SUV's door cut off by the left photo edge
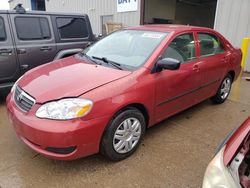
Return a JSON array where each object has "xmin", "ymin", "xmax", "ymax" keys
[{"xmin": 0, "ymin": 14, "xmax": 19, "ymax": 83}]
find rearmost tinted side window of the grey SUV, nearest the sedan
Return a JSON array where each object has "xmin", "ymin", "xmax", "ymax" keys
[{"xmin": 56, "ymin": 18, "xmax": 89, "ymax": 39}]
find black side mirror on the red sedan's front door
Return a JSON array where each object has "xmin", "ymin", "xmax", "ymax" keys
[{"xmin": 155, "ymin": 58, "xmax": 181, "ymax": 72}]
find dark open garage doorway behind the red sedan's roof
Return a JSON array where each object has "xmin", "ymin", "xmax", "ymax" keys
[{"xmin": 142, "ymin": 0, "xmax": 217, "ymax": 28}]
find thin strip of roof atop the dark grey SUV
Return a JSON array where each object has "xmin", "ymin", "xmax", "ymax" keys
[{"xmin": 0, "ymin": 10, "xmax": 87, "ymax": 16}]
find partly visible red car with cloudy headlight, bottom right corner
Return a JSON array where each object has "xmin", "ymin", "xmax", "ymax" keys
[{"xmin": 203, "ymin": 118, "xmax": 250, "ymax": 188}]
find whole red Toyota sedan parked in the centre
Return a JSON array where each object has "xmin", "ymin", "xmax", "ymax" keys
[{"xmin": 7, "ymin": 25, "xmax": 242, "ymax": 160}]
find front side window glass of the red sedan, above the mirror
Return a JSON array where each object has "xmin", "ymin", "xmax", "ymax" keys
[{"xmin": 163, "ymin": 33, "xmax": 196, "ymax": 63}]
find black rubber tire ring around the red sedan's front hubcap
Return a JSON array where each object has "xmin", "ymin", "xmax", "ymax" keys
[{"xmin": 100, "ymin": 108, "xmax": 146, "ymax": 161}]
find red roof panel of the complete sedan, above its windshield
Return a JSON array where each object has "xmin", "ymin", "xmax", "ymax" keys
[{"xmin": 127, "ymin": 24, "xmax": 214, "ymax": 33}]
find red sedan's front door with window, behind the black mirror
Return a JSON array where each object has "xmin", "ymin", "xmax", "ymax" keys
[{"xmin": 155, "ymin": 33, "xmax": 202, "ymax": 121}]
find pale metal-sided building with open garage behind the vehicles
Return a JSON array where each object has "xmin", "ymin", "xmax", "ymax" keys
[{"xmin": 9, "ymin": 0, "xmax": 250, "ymax": 71}]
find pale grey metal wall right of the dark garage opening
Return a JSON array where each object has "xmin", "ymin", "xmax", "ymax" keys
[{"xmin": 214, "ymin": 0, "xmax": 250, "ymax": 71}]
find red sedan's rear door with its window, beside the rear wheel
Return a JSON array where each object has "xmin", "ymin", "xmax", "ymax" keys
[{"xmin": 197, "ymin": 32, "xmax": 230, "ymax": 100}]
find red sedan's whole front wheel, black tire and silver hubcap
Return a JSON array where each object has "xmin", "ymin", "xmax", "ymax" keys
[{"xmin": 100, "ymin": 108, "xmax": 146, "ymax": 161}]
